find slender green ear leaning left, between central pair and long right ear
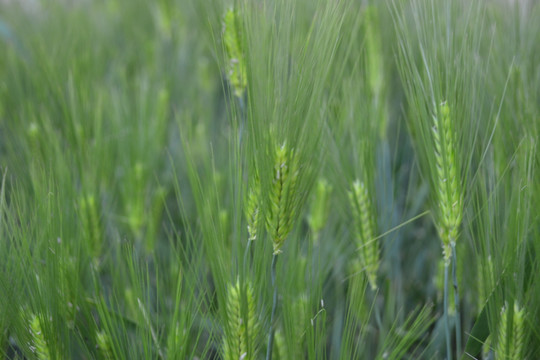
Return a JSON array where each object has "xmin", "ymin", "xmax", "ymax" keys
[{"xmin": 349, "ymin": 180, "xmax": 379, "ymax": 290}]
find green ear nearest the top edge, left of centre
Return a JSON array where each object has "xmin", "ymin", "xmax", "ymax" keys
[{"xmin": 223, "ymin": 9, "xmax": 247, "ymax": 98}]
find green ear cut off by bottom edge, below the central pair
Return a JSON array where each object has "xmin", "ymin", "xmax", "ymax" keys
[{"xmin": 223, "ymin": 280, "xmax": 259, "ymax": 360}]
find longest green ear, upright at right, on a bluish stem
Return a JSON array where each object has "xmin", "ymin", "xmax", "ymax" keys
[{"xmin": 432, "ymin": 102, "xmax": 463, "ymax": 264}]
